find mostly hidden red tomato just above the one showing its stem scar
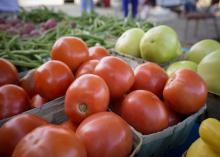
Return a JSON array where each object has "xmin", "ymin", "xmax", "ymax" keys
[{"xmin": 76, "ymin": 59, "xmax": 99, "ymax": 77}]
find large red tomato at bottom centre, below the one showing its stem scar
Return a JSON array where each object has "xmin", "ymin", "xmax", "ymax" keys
[{"xmin": 76, "ymin": 112, "xmax": 132, "ymax": 157}]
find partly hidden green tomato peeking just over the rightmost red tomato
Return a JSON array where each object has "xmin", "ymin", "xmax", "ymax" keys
[{"xmin": 166, "ymin": 61, "xmax": 197, "ymax": 76}]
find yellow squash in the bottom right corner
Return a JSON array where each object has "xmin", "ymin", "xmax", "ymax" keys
[{"xmin": 186, "ymin": 118, "xmax": 220, "ymax": 157}]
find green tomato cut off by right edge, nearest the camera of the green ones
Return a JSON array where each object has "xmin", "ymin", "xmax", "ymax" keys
[{"xmin": 198, "ymin": 49, "xmax": 220, "ymax": 94}]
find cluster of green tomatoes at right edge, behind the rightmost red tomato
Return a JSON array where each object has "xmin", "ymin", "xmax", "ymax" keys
[{"xmin": 166, "ymin": 39, "xmax": 220, "ymax": 95}]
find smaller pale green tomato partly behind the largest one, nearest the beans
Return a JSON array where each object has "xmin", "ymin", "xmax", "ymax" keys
[{"xmin": 115, "ymin": 28, "xmax": 144, "ymax": 57}]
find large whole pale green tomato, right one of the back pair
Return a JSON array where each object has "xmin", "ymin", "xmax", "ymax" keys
[{"xmin": 140, "ymin": 25, "xmax": 180, "ymax": 64}]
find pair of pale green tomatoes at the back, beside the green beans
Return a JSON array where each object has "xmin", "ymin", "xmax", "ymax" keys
[{"xmin": 115, "ymin": 25, "xmax": 182, "ymax": 64}]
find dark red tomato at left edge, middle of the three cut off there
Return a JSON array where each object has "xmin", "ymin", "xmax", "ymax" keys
[{"xmin": 0, "ymin": 84, "xmax": 30, "ymax": 120}]
